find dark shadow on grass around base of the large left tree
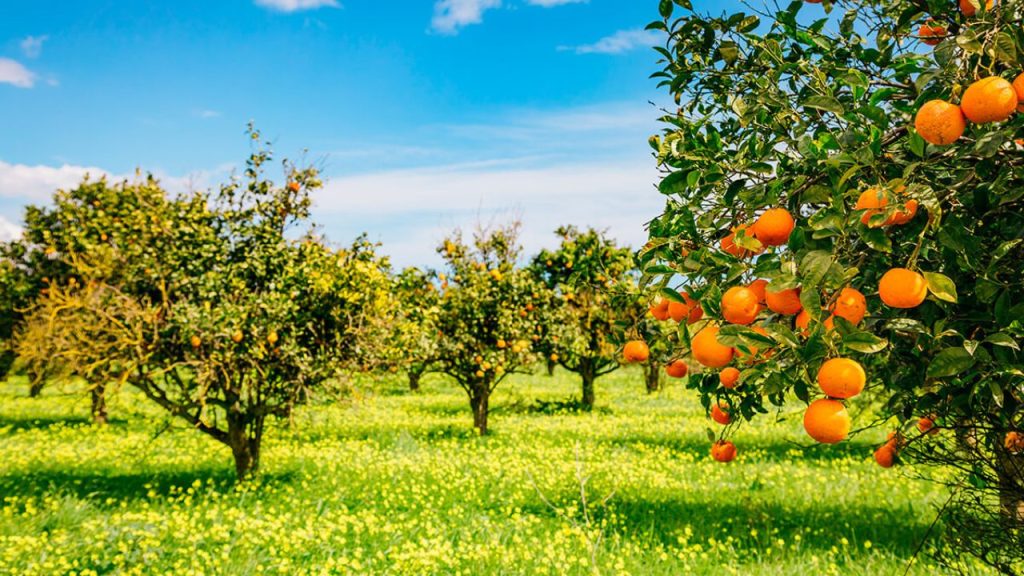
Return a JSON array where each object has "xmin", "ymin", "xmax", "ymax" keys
[{"xmin": 0, "ymin": 467, "xmax": 294, "ymax": 506}]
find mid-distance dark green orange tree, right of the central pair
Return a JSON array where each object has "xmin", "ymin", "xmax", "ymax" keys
[{"xmin": 529, "ymin": 225, "xmax": 635, "ymax": 410}]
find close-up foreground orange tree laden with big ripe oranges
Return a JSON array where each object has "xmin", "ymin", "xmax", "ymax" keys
[{"xmin": 641, "ymin": 0, "xmax": 1024, "ymax": 569}]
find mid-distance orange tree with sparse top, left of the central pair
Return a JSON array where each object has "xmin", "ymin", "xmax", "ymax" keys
[{"xmin": 437, "ymin": 222, "xmax": 548, "ymax": 436}]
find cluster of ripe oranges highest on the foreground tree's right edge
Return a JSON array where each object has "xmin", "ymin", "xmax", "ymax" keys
[{"xmin": 913, "ymin": 74, "xmax": 1024, "ymax": 146}]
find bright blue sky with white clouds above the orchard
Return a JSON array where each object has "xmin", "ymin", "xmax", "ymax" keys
[{"xmin": 0, "ymin": 0, "xmax": 688, "ymax": 264}]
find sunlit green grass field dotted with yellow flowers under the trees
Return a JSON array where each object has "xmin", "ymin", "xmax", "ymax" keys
[{"xmin": 0, "ymin": 369, "xmax": 991, "ymax": 575}]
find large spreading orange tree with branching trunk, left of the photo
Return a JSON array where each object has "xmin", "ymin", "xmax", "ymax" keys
[{"xmin": 14, "ymin": 129, "xmax": 389, "ymax": 479}]
